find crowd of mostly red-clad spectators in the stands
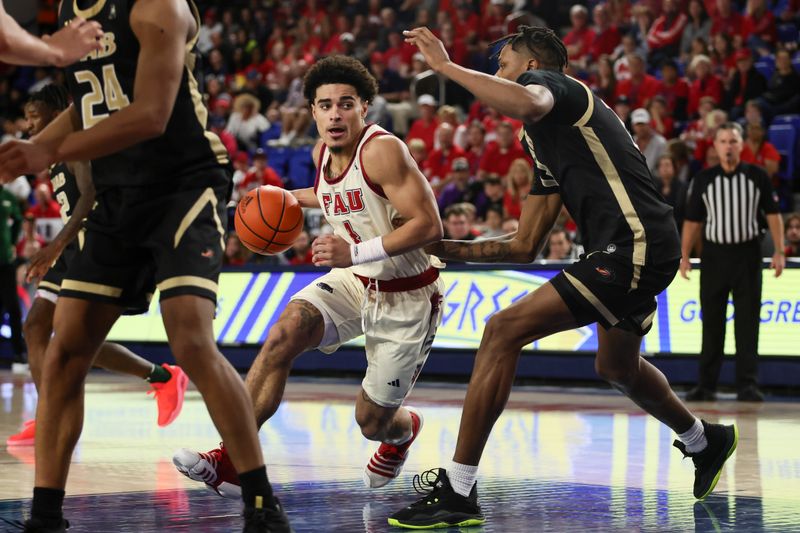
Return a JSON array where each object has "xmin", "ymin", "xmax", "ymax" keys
[{"xmin": 0, "ymin": 0, "xmax": 800, "ymax": 272}]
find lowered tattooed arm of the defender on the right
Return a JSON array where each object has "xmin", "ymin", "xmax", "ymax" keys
[{"xmin": 425, "ymin": 194, "xmax": 561, "ymax": 263}]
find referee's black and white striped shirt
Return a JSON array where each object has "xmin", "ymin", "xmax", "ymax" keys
[{"xmin": 686, "ymin": 163, "xmax": 778, "ymax": 244}]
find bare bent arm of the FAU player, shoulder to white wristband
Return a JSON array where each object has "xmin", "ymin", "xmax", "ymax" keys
[{"xmin": 361, "ymin": 135, "xmax": 444, "ymax": 256}]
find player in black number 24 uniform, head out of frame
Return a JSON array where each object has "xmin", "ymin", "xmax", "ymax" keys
[{"xmin": 0, "ymin": 0, "xmax": 290, "ymax": 532}]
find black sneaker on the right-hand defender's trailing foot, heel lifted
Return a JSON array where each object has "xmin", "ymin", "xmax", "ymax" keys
[{"xmin": 672, "ymin": 420, "xmax": 739, "ymax": 500}]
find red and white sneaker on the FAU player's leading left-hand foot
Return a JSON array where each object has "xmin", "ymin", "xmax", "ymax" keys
[{"xmin": 172, "ymin": 443, "xmax": 242, "ymax": 500}]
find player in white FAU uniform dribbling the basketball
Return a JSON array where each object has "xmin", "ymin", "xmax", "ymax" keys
[{"xmin": 173, "ymin": 56, "xmax": 444, "ymax": 498}]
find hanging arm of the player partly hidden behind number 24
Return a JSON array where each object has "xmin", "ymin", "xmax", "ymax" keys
[{"xmin": 25, "ymin": 161, "xmax": 95, "ymax": 283}]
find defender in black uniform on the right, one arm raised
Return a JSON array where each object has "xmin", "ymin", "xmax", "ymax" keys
[{"xmin": 389, "ymin": 26, "xmax": 737, "ymax": 528}]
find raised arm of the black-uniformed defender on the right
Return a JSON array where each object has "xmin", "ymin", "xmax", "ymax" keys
[{"xmin": 403, "ymin": 27, "xmax": 554, "ymax": 123}]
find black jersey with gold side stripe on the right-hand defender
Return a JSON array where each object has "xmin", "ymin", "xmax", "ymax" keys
[{"xmin": 517, "ymin": 70, "xmax": 680, "ymax": 272}]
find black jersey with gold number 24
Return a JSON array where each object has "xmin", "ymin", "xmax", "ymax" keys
[{"xmin": 59, "ymin": 0, "xmax": 229, "ymax": 189}]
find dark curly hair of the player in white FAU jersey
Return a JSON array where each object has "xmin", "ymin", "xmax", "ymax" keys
[{"xmin": 303, "ymin": 55, "xmax": 378, "ymax": 104}]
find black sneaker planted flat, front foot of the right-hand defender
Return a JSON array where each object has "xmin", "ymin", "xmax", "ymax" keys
[{"xmin": 389, "ymin": 468, "xmax": 486, "ymax": 529}]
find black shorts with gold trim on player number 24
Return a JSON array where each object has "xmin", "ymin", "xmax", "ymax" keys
[{"xmin": 60, "ymin": 168, "xmax": 230, "ymax": 308}]
